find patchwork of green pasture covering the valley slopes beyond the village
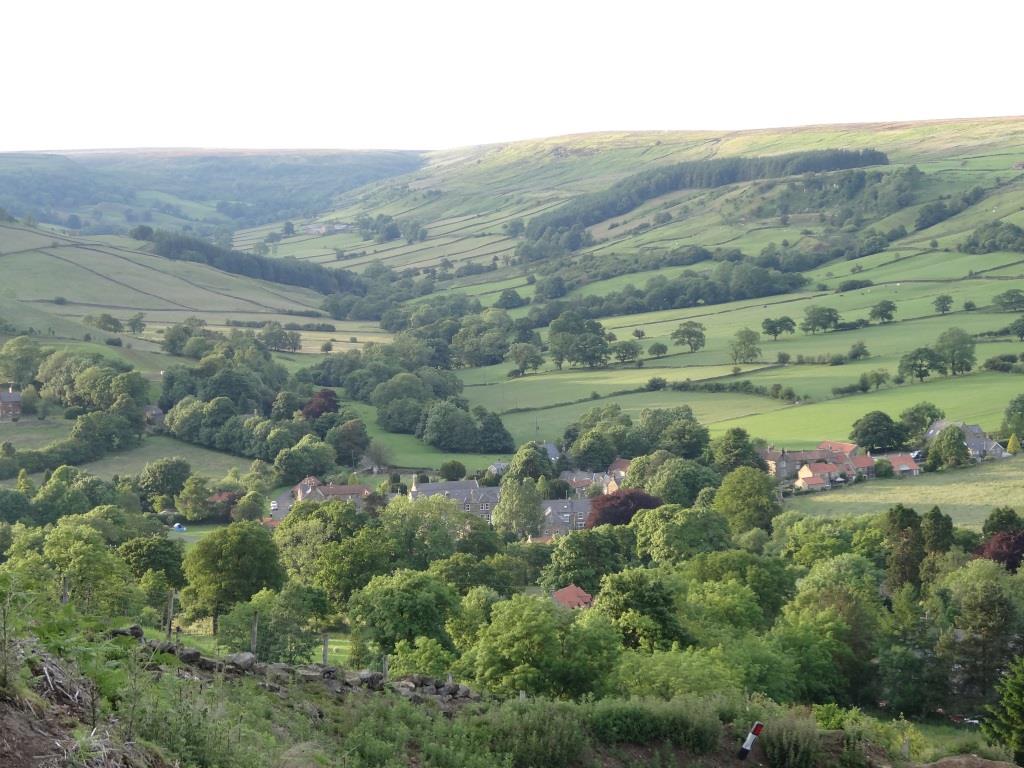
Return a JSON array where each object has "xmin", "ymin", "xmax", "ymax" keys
[{"xmin": 0, "ymin": 119, "xmax": 1024, "ymax": 475}]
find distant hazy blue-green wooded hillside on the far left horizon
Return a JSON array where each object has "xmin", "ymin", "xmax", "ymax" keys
[{"xmin": 0, "ymin": 151, "xmax": 422, "ymax": 234}]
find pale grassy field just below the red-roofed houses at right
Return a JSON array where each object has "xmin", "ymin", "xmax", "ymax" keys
[{"xmin": 785, "ymin": 457, "xmax": 1024, "ymax": 529}]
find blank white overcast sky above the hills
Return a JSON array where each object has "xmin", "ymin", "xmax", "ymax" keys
[{"xmin": 0, "ymin": 0, "xmax": 1024, "ymax": 151}]
